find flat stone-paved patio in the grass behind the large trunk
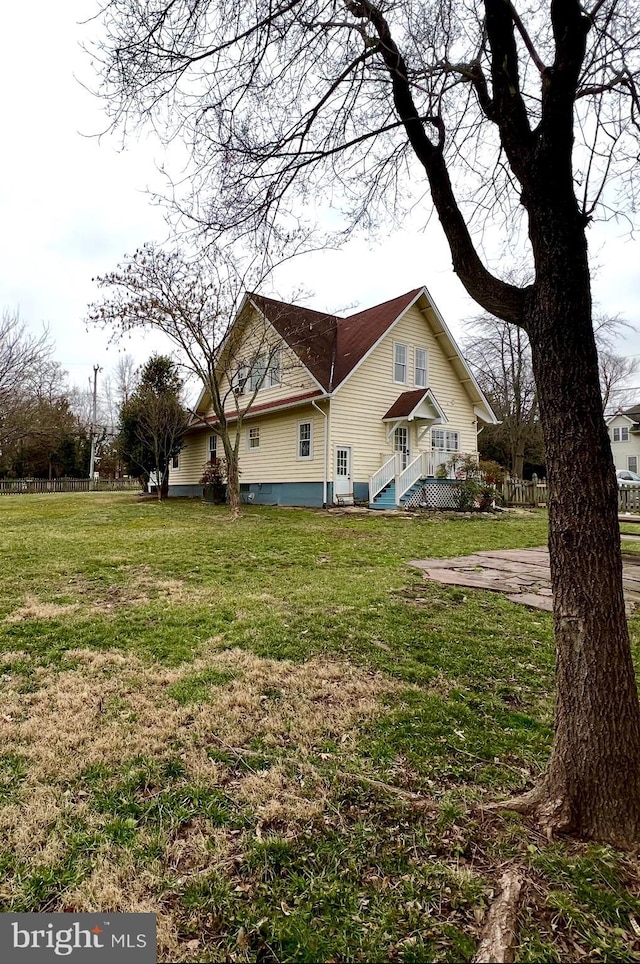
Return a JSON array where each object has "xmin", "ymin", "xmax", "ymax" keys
[{"xmin": 409, "ymin": 548, "xmax": 640, "ymax": 612}]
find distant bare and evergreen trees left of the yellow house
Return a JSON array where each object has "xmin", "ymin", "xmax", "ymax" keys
[{"xmin": 0, "ymin": 311, "xmax": 187, "ymax": 493}]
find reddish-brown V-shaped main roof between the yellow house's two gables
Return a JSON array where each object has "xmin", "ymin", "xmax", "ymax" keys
[{"xmin": 249, "ymin": 288, "xmax": 422, "ymax": 392}]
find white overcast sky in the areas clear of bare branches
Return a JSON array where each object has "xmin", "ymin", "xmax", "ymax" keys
[{"xmin": 0, "ymin": 0, "xmax": 640, "ymax": 395}]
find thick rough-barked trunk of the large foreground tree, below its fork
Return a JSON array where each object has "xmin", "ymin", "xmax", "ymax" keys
[{"xmin": 527, "ymin": 205, "xmax": 640, "ymax": 846}]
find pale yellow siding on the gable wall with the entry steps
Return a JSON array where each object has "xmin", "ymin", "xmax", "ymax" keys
[{"xmin": 329, "ymin": 306, "xmax": 477, "ymax": 482}]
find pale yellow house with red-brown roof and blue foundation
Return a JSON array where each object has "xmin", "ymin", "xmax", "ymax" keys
[{"xmin": 169, "ymin": 288, "xmax": 497, "ymax": 507}]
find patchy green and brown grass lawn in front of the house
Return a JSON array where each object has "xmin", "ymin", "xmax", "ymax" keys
[{"xmin": 0, "ymin": 493, "xmax": 640, "ymax": 962}]
